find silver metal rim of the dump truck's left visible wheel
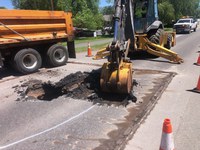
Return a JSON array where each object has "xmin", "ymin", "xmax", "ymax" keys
[{"xmin": 22, "ymin": 54, "xmax": 37, "ymax": 69}]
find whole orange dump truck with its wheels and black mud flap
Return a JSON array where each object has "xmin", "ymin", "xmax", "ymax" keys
[{"xmin": 0, "ymin": 9, "xmax": 76, "ymax": 74}]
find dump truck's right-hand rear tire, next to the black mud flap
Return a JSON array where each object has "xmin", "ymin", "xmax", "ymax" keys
[{"xmin": 47, "ymin": 44, "xmax": 69, "ymax": 67}]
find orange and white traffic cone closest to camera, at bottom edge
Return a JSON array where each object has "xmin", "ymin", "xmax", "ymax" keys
[{"xmin": 160, "ymin": 119, "xmax": 174, "ymax": 150}]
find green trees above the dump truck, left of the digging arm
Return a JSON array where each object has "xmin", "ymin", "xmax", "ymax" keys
[{"xmin": 12, "ymin": 0, "xmax": 103, "ymax": 29}]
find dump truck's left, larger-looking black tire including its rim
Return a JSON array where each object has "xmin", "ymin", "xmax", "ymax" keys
[{"xmin": 13, "ymin": 48, "xmax": 42, "ymax": 74}]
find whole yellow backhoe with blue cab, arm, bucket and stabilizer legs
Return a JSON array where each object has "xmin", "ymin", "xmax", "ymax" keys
[{"xmin": 94, "ymin": 0, "xmax": 183, "ymax": 94}]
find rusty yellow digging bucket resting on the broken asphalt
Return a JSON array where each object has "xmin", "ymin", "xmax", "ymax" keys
[{"xmin": 100, "ymin": 62, "xmax": 133, "ymax": 94}]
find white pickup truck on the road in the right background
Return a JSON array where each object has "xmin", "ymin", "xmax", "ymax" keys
[{"xmin": 173, "ymin": 18, "xmax": 197, "ymax": 34}]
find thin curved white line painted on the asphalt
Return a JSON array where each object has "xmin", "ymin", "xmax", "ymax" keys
[{"xmin": 0, "ymin": 105, "xmax": 95, "ymax": 150}]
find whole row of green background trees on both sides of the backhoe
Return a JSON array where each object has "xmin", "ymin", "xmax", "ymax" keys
[{"xmin": 12, "ymin": 0, "xmax": 200, "ymax": 29}]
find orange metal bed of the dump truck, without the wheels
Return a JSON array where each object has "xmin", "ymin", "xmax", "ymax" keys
[{"xmin": 0, "ymin": 10, "xmax": 74, "ymax": 47}]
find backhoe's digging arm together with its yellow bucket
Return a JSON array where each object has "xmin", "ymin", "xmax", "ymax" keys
[{"xmin": 99, "ymin": 0, "xmax": 133, "ymax": 94}]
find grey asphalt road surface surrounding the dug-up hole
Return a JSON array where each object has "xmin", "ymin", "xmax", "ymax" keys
[{"xmin": 0, "ymin": 30, "xmax": 200, "ymax": 150}]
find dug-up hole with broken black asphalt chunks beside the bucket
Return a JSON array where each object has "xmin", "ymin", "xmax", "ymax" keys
[{"xmin": 14, "ymin": 70, "xmax": 137, "ymax": 106}]
